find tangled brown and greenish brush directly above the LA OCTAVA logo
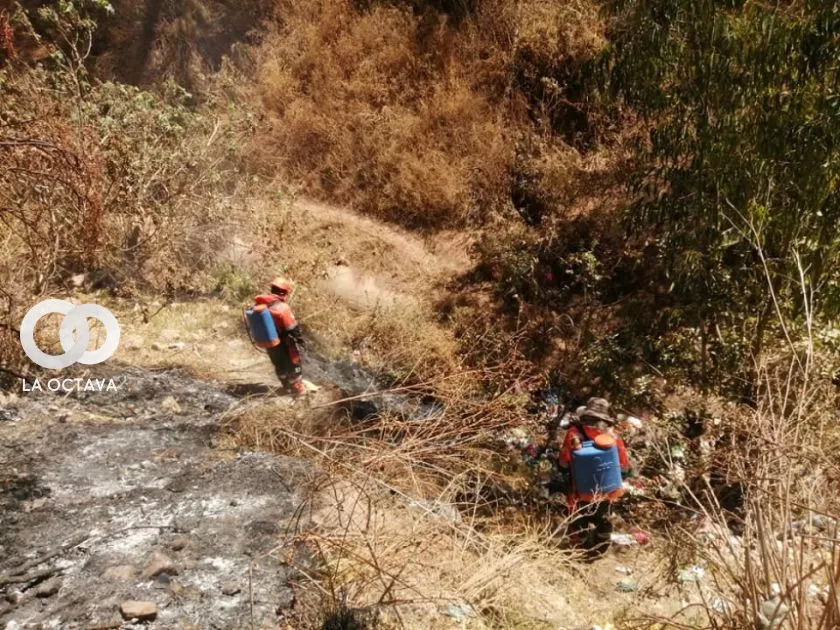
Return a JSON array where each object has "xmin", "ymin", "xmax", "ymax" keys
[{"xmin": 0, "ymin": 59, "xmax": 253, "ymax": 376}]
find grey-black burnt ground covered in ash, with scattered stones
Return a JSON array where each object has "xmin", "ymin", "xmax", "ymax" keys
[{"xmin": 0, "ymin": 368, "xmax": 310, "ymax": 629}]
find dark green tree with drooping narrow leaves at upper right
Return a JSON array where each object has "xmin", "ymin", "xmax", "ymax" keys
[{"xmin": 606, "ymin": 0, "xmax": 840, "ymax": 396}]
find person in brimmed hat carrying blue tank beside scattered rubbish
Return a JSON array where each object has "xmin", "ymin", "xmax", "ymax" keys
[{"xmin": 558, "ymin": 398, "xmax": 629, "ymax": 554}]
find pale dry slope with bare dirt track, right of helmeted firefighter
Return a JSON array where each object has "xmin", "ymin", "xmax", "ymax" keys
[{"xmin": 208, "ymin": 191, "xmax": 466, "ymax": 382}]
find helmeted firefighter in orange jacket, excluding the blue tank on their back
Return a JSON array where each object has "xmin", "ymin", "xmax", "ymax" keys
[{"xmin": 253, "ymin": 278, "xmax": 306, "ymax": 394}]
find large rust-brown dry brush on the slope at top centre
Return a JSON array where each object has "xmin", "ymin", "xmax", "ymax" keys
[{"xmin": 246, "ymin": 0, "xmax": 608, "ymax": 228}]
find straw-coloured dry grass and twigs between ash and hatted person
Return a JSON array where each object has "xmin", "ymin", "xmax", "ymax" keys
[{"xmin": 225, "ymin": 392, "xmax": 592, "ymax": 628}]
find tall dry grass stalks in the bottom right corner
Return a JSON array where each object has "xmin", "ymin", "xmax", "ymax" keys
[{"xmin": 648, "ymin": 254, "xmax": 840, "ymax": 630}]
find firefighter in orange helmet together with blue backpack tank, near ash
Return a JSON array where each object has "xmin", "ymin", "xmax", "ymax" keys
[{"xmin": 246, "ymin": 278, "xmax": 306, "ymax": 394}]
